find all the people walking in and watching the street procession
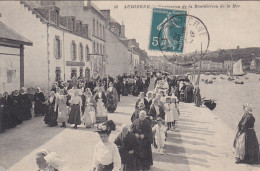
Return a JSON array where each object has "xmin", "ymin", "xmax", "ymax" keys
[{"xmin": 0, "ymin": 72, "xmax": 260, "ymax": 171}]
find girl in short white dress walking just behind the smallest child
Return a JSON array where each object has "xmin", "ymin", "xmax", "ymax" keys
[{"xmin": 164, "ymin": 97, "xmax": 175, "ymax": 130}]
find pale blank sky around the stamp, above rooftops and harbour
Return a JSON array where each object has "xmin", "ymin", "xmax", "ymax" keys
[{"xmin": 92, "ymin": 1, "xmax": 260, "ymax": 56}]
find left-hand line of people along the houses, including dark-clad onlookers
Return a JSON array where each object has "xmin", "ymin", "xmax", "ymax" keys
[{"xmin": 0, "ymin": 74, "xmax": 150, "ymax": 132}]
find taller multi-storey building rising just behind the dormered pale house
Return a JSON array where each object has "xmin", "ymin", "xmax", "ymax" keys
[{"xmin": 53, "ymin": 1, "xmax": 107, "ymax": 78}]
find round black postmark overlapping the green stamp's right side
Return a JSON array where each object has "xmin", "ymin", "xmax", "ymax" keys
[{"xmin": 158, "ymin": 14, "xmax": 210, "ymax": 65}]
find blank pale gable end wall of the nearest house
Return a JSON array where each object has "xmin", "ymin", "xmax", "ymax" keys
[{"xmin": 0, "ymin": 1, "xmax": 48, "ymax": 90}]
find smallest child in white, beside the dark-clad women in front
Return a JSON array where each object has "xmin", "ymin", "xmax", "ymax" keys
[{"xmin": 152, "ymin": 117, "xmax": 166, "ymax": 155}]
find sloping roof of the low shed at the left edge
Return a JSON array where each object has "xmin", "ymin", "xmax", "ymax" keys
[{"xmin": 0, "ymin": 21, "xmax": 32, "ymax": 46}]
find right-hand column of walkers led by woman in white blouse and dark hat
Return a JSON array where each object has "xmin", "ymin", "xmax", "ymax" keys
[{"xmin": 93, "ymin": 72, "xmax": 184, "ymax": 171}]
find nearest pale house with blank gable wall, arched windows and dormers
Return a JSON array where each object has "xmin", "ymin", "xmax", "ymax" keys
[{"xmin": 0, "ymin": 1, "xmax": 92, "ymax": 91}]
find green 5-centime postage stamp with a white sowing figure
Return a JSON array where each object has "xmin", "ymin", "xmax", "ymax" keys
[{"xmin": 149, "ymin": 8, "xmax": 187, "ymax": 53}]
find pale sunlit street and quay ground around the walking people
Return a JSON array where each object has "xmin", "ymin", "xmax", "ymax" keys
[{"xmin": 0, "ymin": 88, "xmax": 260, "ymax": 171}]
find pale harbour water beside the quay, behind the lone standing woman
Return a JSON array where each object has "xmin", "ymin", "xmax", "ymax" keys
[{"xmin": 200, "ymin": 73, "xmax": 260, "ymax": 142}]
